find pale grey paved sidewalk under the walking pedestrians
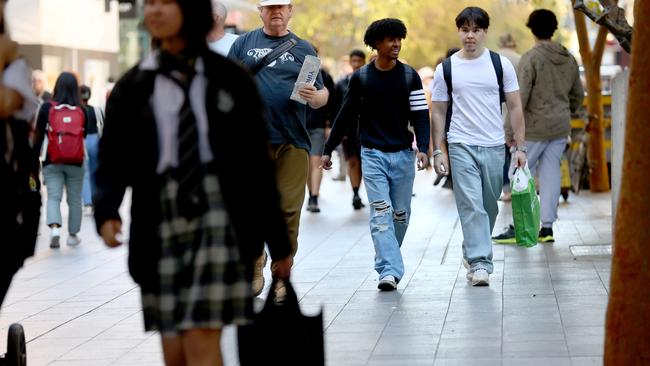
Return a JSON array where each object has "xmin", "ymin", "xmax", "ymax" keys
[{"xmin": 0, "ymin": 167, "xmax": 611, "ymax": 366}]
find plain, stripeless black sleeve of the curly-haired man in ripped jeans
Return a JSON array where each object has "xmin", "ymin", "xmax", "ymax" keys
[{"xmin": 323, "ymin": 73, "xmax": 361, "ymax": 156}]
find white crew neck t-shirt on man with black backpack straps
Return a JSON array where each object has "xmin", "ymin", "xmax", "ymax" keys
[{"xmin": 431, "ymin": 48, "xmax": 519, "ymax": 147}]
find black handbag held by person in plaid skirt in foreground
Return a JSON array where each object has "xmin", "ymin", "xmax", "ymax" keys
[{"xmin": 237, "ymin": 279, "xmax": 325, "ymax": 366}]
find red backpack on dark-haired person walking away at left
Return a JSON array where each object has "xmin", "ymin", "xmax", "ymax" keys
[{"xmin": 47, "ymin": 102, "xmax": 86, "ymax": 164}]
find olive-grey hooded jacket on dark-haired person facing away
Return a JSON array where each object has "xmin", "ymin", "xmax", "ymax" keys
[{"xmin": 517, "ymin": 42, "xmax": 584, "ymax": 141}]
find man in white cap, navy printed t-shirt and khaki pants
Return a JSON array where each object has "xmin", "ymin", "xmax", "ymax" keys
[{"xmin": 228, "ymin": 0, "xmax": 329, "ymax": 297}]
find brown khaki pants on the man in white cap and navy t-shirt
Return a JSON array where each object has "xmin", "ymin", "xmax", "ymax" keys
[{"xmin": 258, "ymin": 144, "xmax": 309, "ymax": 263}]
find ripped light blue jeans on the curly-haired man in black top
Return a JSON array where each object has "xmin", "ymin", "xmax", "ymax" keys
[{"xmin": 361, "ymin": 147, "xmax": 415, "ymax": 282}]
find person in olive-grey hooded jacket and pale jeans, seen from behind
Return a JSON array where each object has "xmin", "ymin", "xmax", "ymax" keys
[{"xmin": 493, "ymin": 9, "xmax": 584, "ymax": 243}]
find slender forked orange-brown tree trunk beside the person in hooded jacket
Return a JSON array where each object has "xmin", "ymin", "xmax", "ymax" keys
[{"xmin": 573, "ymin": 1, "xmax": 609, "ymax": 192}]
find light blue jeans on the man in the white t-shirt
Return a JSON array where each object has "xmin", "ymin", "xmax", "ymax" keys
[{"xmin": 449, "ymin": 144, "xmax": 505, "ymax": 273}]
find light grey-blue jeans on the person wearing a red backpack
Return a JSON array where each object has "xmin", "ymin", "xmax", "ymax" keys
[{"xmin": 43, "ymin": 164, "xmax": 84, "ymax": 234}]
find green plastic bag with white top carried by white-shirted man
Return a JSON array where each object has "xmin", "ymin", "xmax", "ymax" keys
[{"xmin": 510, "ymin": 164, "xmax": 540, "ymax": 247}]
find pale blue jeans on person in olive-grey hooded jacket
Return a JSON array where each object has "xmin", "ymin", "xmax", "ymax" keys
[{"xmin": 526, "ymin": 137, "xmax": 567, "ymax": 227}]
